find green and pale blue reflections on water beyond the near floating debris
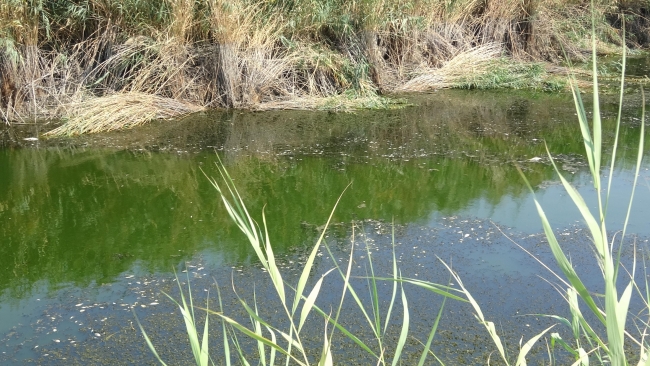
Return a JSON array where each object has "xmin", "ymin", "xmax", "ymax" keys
[{"xmin": 0, "ymin": 91, "xmax": 650, "ymax": 364}]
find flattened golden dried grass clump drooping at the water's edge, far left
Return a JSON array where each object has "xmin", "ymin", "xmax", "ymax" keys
[{"xmin": 46, "ymin": 93, "xmax": 203, "ymax": 136}]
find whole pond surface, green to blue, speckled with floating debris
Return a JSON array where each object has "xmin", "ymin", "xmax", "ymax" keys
[{"xmin": 0, "ymin": 90, "xmax": 650, "ymax": 364}]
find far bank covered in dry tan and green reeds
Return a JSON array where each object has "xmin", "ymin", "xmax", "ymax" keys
[{"xmin": 0, "ymin": 0, "xmax": 650, "ymax": 134}]
